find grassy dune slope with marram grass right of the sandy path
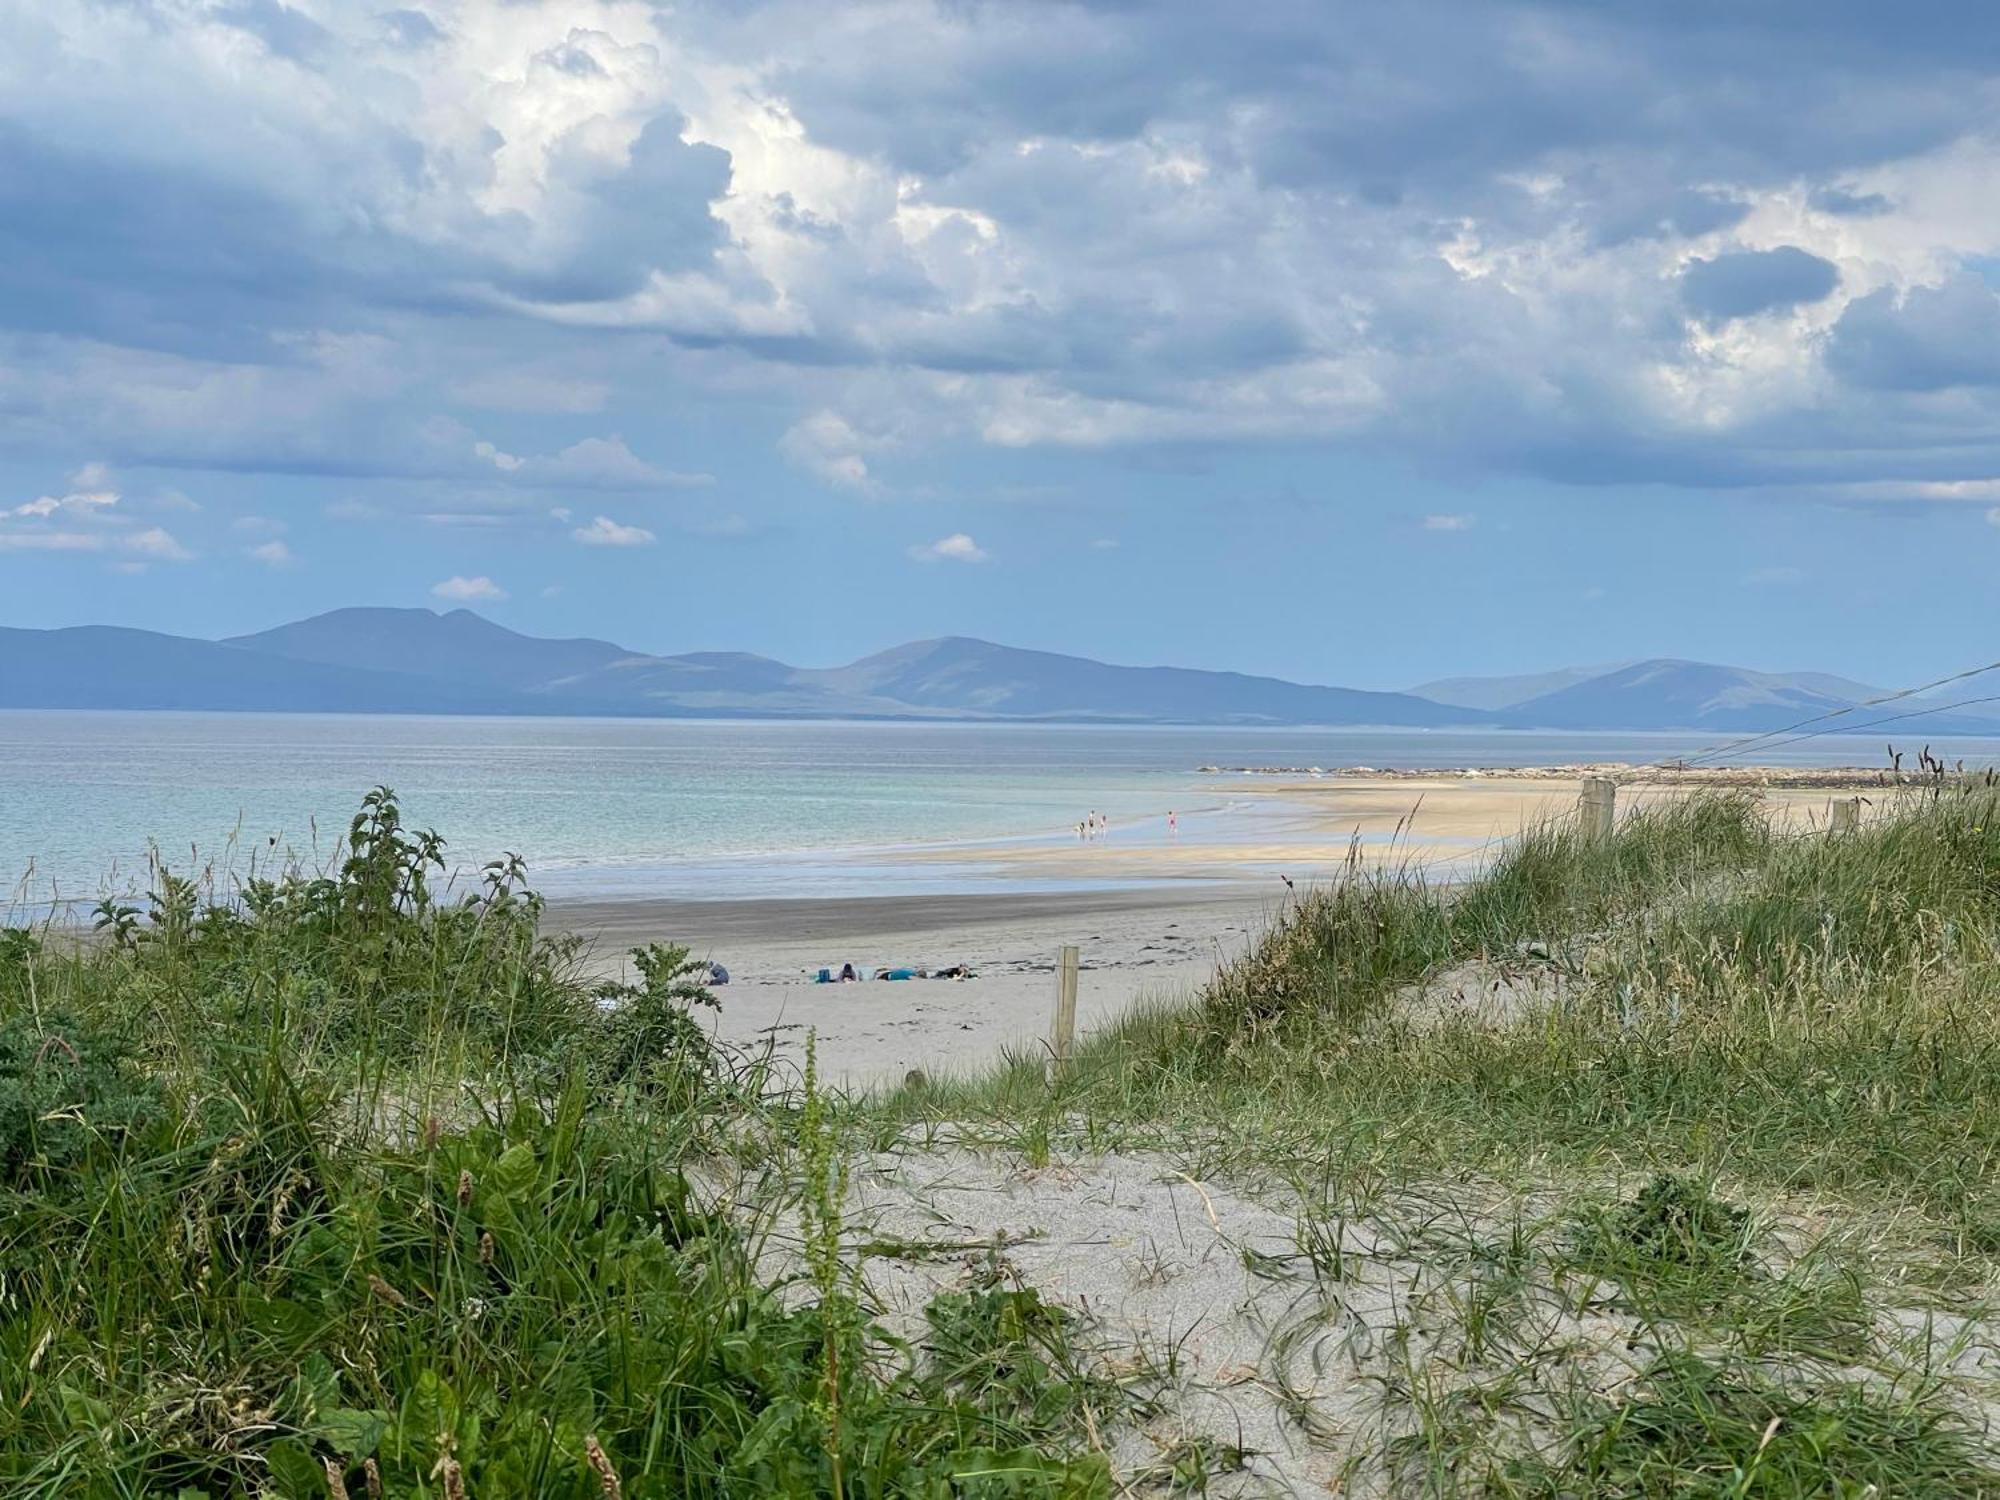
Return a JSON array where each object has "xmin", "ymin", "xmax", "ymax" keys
[{"xmin": 884, "ymin": 784, "xmax": 2000, "ymax": 1496}]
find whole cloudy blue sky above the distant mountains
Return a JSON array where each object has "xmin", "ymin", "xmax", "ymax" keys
[{"xmin": 0, "ymin": 0, "xmax": 2000, "ymax": 688}]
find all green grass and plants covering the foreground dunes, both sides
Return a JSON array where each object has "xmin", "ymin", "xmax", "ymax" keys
[{"xmin": 11, "ymin": 786, "xmax": 2000, "ymax": 1500}]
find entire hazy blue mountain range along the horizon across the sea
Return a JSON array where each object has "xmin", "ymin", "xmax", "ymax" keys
[{"xmin": 0, "ymin": 608, "xmax": 2000, "ymax": 736}]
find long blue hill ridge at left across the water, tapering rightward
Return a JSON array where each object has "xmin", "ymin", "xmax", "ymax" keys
[{"xmin": 0, "ymin": 608, "xmax": 1486, "ymax": 726}]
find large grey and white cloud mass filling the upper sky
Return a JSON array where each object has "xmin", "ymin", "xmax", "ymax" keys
[{"xmin": 0, "ymin": 0, "xmax": 2000, "ymax": 506}]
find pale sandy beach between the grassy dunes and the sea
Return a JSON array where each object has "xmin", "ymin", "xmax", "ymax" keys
[{"xmin": 550, "ymin": 772, "xmax": 1880, "ymax": 1086}]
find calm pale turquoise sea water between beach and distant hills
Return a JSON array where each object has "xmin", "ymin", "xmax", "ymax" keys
[{"xmin": 0, "ymin": 710, "xmax": 2000, "ymax": 908}]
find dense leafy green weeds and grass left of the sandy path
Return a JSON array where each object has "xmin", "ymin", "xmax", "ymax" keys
[{"xmin": 0, "ymin": 792, "xmax": 1110, "ymax": 1500}]
